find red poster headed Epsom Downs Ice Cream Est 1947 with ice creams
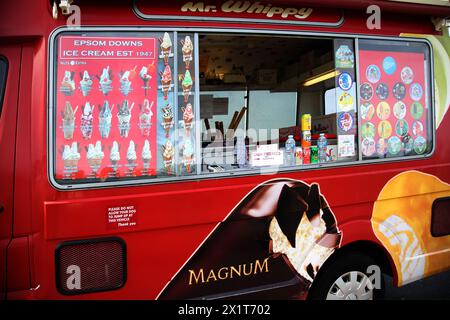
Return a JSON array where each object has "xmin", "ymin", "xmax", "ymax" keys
[{"xmin": 54, "ymin": 36, "xmax": 158, "ymax": 180}]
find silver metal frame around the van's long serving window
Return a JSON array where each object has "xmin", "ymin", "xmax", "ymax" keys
[{"xmin": 47, "ymin": 26, "xmax": 436, "ymax": 191}]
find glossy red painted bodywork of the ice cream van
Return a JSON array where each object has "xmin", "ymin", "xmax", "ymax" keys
[{"xmin": 0, "ymin": 0, "xmax": 450, "ymax": 299}]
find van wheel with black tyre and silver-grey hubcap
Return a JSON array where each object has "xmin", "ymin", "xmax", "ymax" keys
[{"xmin": 308, "ymin": 252, "xmax": 385, "ymax": 300}]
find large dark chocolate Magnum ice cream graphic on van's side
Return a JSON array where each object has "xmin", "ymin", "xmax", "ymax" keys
[{"xmin": 158, "ymin": 179, "xmax": 341, "ymax": 299}]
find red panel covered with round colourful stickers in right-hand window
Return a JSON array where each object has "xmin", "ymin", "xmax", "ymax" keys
[{"xmin": 359, "ymin": 50, "xmax": 429, "ymax": 159}]
